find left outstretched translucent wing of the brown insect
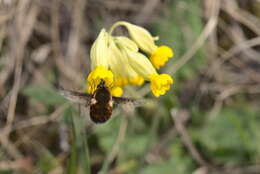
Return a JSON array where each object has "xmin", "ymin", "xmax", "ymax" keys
[{"xmin": 58, "ymin": 87, "xmax": 92, "ymax": 106}]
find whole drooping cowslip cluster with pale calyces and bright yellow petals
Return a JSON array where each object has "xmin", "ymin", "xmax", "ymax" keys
[{"xmin": 87, "ymin": 21, "xmax": 173, "ymax": 97}]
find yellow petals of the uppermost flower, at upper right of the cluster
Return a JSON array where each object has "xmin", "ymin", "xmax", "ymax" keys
[{"xmin": 150, "ymin": 45, "xmax": 174, "ymax": 69}]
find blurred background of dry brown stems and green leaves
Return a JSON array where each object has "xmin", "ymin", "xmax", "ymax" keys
[{"xmin": 0, "ymin": 0, "xmax": 260, "ymax": 174}]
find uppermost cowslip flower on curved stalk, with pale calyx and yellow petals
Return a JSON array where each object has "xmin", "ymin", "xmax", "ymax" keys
[{"xmin": 109, "ymin": 21, "xmax": 174, "ymax": 69}]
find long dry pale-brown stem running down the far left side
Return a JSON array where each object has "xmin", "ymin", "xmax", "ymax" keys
[{"xmin": 0, "ymin": 0, "xmax": 39, "ymax": 158}]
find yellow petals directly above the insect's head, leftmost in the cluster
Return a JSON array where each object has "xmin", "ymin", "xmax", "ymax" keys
[{"xmin": 87, "ymin": 66, "xmax": 114, "ymax": 94}]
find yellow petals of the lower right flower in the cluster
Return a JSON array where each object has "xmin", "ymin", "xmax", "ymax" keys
[{"xmin": 150, "ymin": 74, "xmax": 173, "ymax": 97}]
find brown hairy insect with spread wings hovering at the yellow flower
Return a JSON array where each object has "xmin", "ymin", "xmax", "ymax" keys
[{"xmin": 59, "ymin": 79, "xmax": 139, "ymax": 123}]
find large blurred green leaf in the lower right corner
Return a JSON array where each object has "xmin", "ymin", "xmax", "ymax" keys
[{"xmin": 193, "ymin": 106, "xmax": 260, "ymax": 163}]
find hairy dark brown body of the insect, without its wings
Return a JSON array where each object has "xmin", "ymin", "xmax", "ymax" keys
[{"xmin": 90, "ymin": 81, "xmax": 113, "ymax": 123}]
